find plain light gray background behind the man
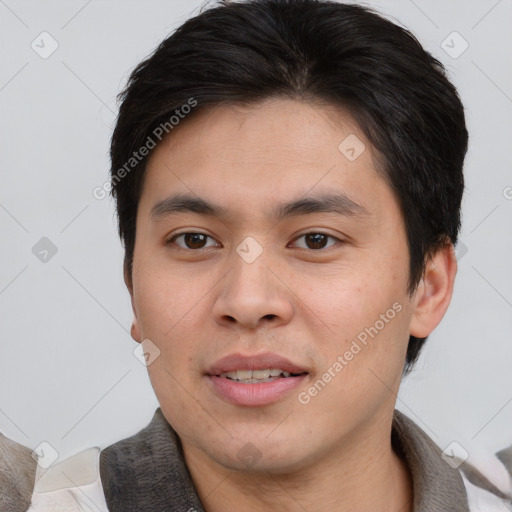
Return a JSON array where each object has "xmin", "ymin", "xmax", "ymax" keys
[{"xmin": 0, "ymin": 0, "xmax": 512, "ymax": 468}]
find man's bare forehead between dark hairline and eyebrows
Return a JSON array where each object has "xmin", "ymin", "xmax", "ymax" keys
[{"xmin": 141, "ymin": 98, "xmax": 390, "ymax": 220}]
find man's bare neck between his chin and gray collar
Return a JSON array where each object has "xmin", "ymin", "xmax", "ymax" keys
[{"xmin": 183, "ymin": 412, "xmax": 413, "ymax": 512}]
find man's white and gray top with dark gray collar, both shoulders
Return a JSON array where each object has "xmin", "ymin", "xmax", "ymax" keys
[{"xmin": 21, "ymin": 409, "xmax": 512, "ymax": 512}]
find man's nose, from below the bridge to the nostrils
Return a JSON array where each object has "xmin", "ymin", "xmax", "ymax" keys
[{"xmin": 213, "ymin": 254, "xmax": 294, "ymax": 329}]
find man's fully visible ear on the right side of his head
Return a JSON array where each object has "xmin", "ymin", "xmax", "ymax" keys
[{"xmin": 410, "ymin": 242, "xmax": 457, "ymax": 338}]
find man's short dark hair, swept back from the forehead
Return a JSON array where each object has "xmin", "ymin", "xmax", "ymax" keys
[{"xmin": 110, "ymin": 0, "xmax": 468, "ymax": 373}]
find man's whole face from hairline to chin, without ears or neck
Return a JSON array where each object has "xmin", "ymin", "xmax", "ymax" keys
[{"xmin": 131, "ymin": 99, "xmax": 422, "ymax": 472}]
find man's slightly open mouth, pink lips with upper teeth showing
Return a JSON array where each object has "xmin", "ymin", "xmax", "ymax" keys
[{"xmin": 206, "ymin": 353, "xmax": 309, "ymax": 407}]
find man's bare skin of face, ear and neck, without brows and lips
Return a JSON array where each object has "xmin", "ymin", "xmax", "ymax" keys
[{"xmin": 125, "ymin": 99, "xmax": 456, "ymax": 512}]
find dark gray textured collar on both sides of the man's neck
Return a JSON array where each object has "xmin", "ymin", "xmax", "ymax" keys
[{"xmin": 100, "ymin": 409, "xmax": 469, "ymax": 512}]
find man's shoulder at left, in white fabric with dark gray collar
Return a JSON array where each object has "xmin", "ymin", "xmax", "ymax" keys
[{"xmin": 25, "ymin": 410, "xmax": 203, "ymax": 512}]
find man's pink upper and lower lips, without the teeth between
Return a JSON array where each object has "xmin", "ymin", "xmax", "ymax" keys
[{"xmin": 206, "ymin": 352, "xmax": 309, "ymax": 407}]
